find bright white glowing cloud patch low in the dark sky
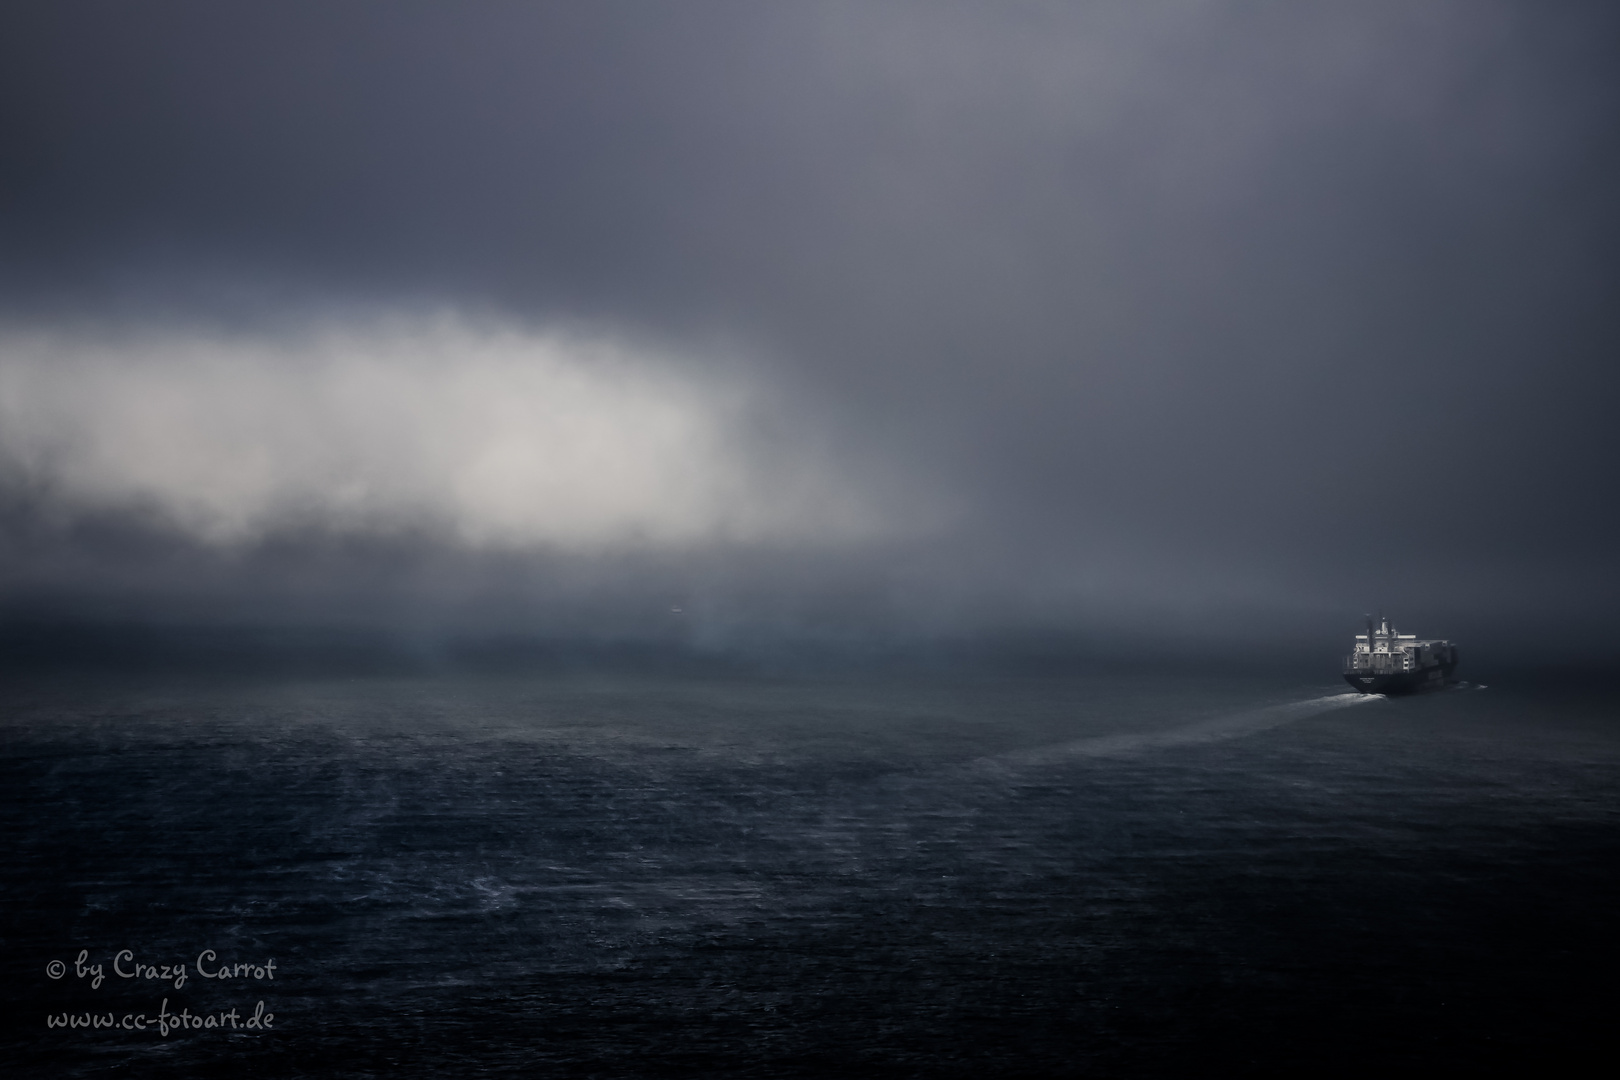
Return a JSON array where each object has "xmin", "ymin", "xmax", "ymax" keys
[{"xmin": 0, "ymin": 317, "xmax": 893, "ymax": 551}]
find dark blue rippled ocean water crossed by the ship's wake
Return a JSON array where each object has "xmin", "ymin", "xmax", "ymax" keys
[{"xmin": 0, "ymin": 672, "xmax": 1620, "ymax": 1077}]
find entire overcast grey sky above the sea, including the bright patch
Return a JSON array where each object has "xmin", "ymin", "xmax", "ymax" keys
[{"xmin": 0, "ymin": 0, "xmax": 1620, "ymax": 651}]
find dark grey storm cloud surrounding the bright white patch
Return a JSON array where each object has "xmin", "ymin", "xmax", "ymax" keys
[{"xmin": 0, "ymin": 3, "xmax": 1620, "ymax": 643}]
